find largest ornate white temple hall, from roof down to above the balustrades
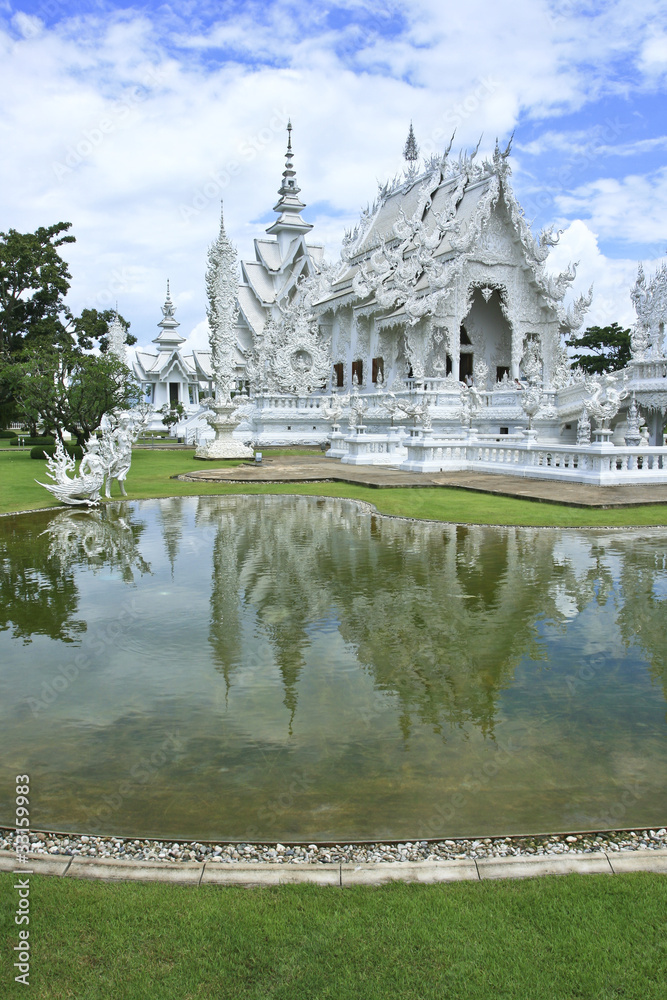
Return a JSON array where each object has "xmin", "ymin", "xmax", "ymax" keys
[{"xmin": 315, "ymin": 137, "xmax": 590, "ymax": 391}]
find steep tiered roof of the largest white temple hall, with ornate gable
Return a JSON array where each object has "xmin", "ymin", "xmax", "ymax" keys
[{"xmin": 316, "ymin": 142, "xmax": 590, "ymax": 332}]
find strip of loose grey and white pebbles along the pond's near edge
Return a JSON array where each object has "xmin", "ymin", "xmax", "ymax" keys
[{"xmin": 0, "ymin": 827, "xmax": 667, "ymax": 868}]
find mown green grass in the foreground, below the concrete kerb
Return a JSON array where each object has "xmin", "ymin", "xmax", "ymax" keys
[{"xmin": 0, "ymin": 873, "xmax": 667, "ymax": 1000}]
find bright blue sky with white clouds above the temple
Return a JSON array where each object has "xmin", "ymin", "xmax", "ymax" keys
[{"xmin": 0, "ymin": 0, "xmax": 667, "ymax": 346}]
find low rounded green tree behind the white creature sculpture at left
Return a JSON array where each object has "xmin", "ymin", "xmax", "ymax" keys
[{"xmin": 0, "ymin": 344, "xmax": 137, "ymax": 444}]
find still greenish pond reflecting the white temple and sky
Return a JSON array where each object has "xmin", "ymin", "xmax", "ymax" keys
[{"xmin": 0, "ymin": 497, "xmax": 667, "ymax": 842}]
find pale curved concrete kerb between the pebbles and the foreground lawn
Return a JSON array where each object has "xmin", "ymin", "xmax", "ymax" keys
[{"xmin": 0, "ymin": 849, "xmax": 667, "ymax": 888}]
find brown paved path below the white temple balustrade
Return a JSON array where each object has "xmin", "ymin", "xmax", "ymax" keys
[{"xmin": 178, "ymin": 454, "xmax": 667, "ymax": 507}]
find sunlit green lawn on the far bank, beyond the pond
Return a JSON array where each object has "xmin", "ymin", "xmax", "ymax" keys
[{"xmin": 0, "ymin": 448, "xmax": 667, "ymax": 527}]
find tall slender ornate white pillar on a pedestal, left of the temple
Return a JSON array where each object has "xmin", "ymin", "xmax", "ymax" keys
[{"xmin": 195, "ymin": 210, "xmax": 253, "ymax": 459}]
